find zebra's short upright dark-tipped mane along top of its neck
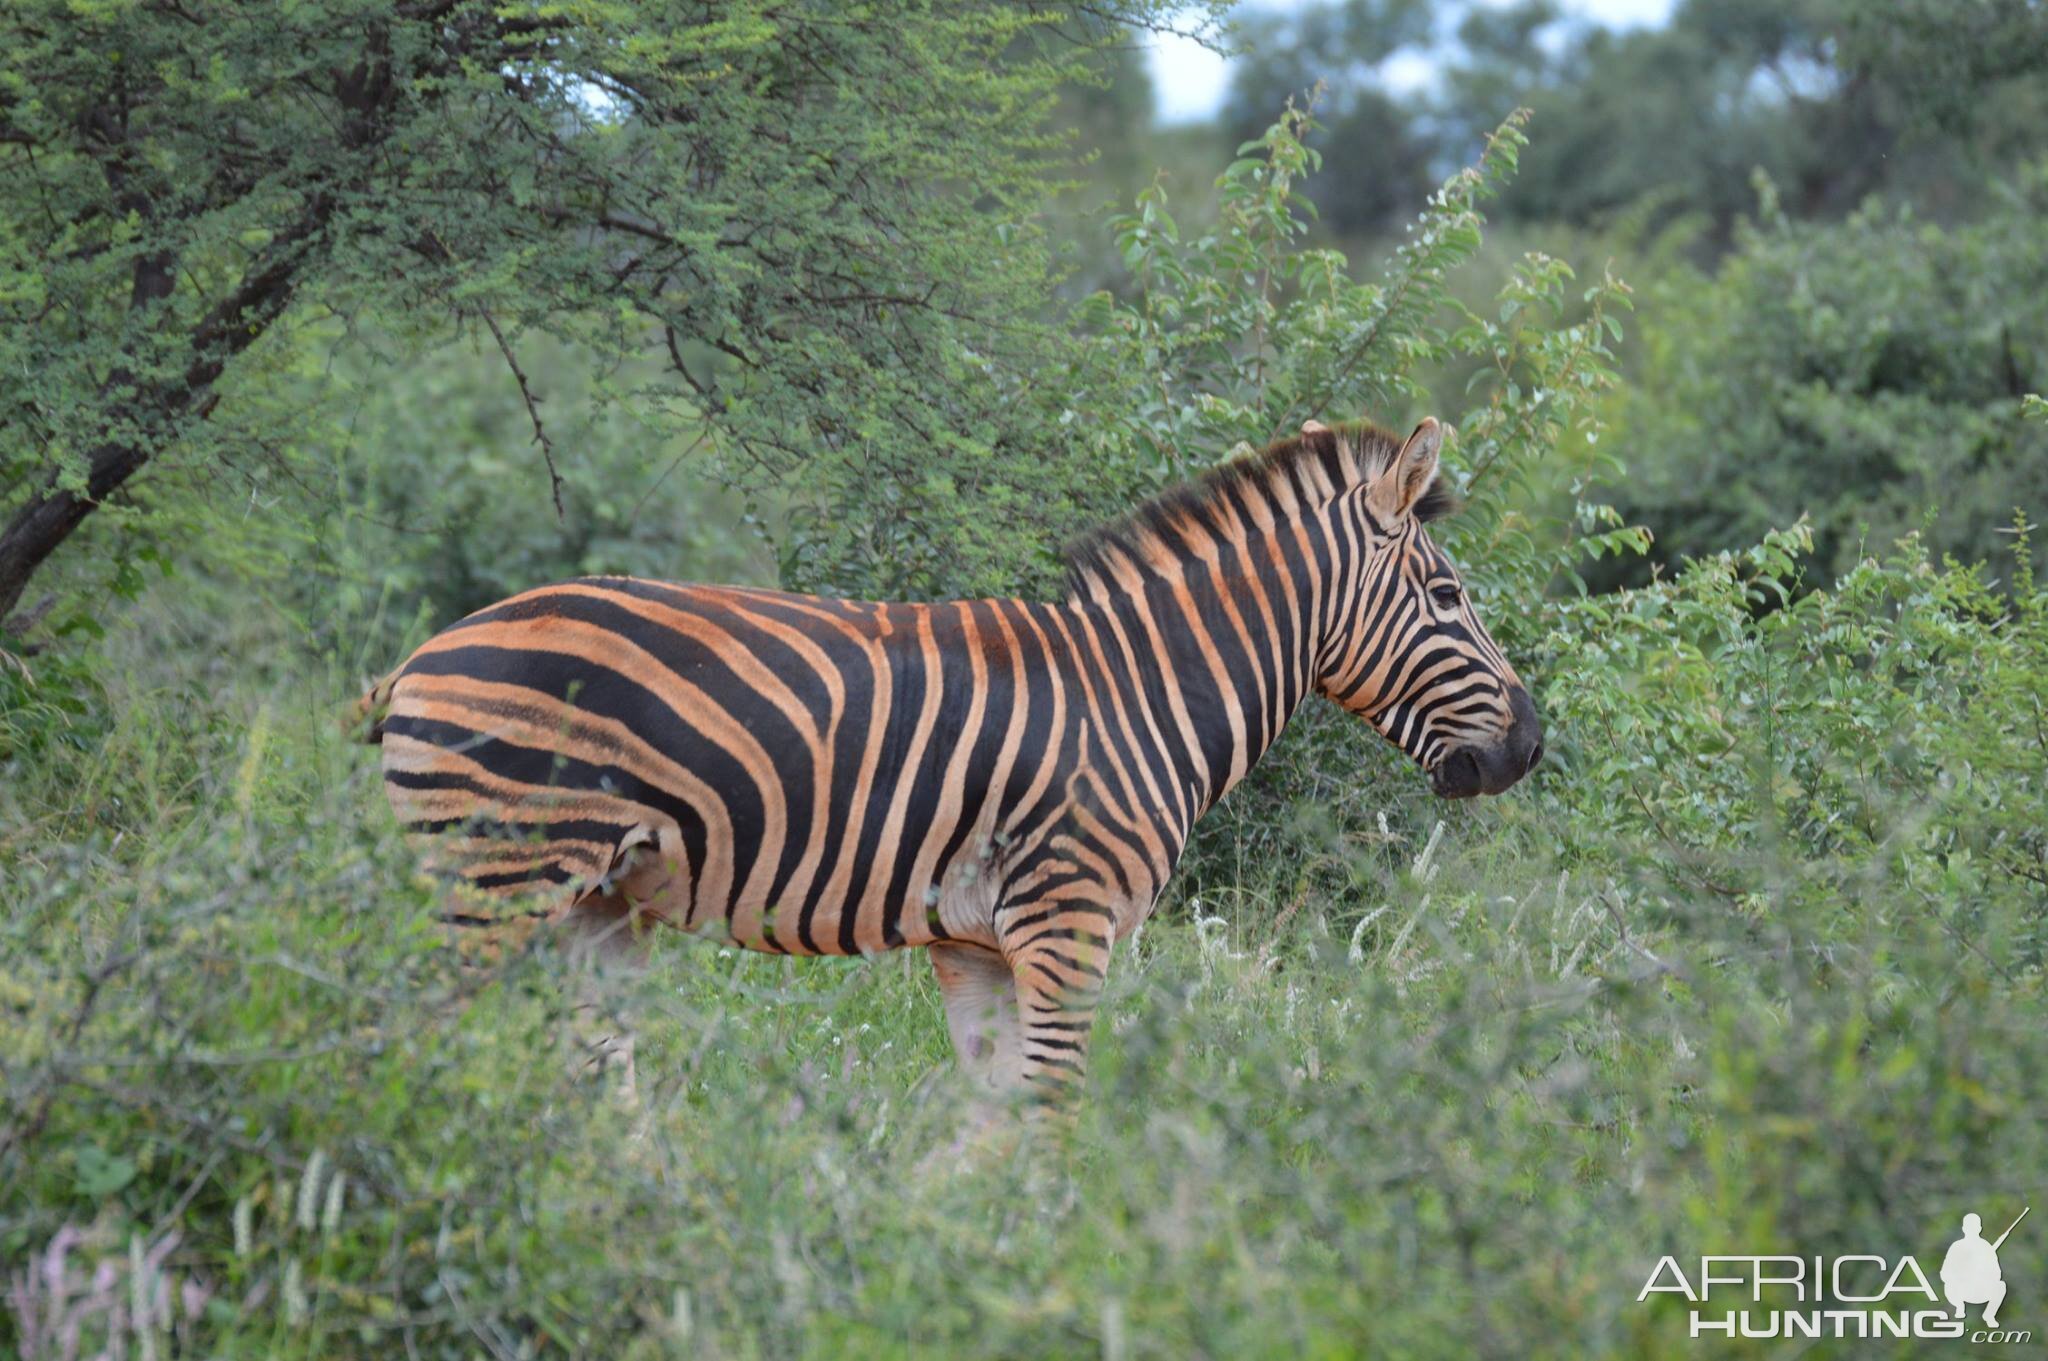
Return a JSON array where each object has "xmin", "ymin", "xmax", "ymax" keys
[{"xmin": 1065, "ymin": 422, "xmax": 1456, "ymax": 596}]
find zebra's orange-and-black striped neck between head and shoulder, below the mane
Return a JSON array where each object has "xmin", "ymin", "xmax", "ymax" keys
[{"xmin": 1063, "ymin": 491, "xmax": 1350, "ymax": 841}]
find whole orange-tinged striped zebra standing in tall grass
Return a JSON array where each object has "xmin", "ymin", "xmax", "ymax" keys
[{"xmin": 360, "ymin": 420, "xmax": 1542, "ymax": 1105}]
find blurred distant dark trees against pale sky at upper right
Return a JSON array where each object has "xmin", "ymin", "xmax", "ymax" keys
[{"xmin": 1442, "ymin": 0, "xmax": 2048, "ymax": 242}]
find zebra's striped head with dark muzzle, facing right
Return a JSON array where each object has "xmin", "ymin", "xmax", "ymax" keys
[{"xmin": 1303, "ymin": 420, "xmax": 1542, "ymax": 798}]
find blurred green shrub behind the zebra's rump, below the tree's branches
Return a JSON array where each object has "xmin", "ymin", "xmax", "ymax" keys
[{"xmin": 245, "ymin": 332, "xmax": 780, "ymax": 673}]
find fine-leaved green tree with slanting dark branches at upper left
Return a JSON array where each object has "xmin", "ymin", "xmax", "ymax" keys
[{"xmin": 0, "ymin": 0, "xmax": 1196, "ymax": 618}]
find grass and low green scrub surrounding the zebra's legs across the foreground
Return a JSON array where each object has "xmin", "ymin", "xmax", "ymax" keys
[{"xmin": 0, "ymin": 501, "xmax": 2048, "ymax": 1357}]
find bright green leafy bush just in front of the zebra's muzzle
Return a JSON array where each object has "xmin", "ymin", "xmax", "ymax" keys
[{"xmin": 1540, "ymin": 515, "xmax": 2048, "ymax": 941}]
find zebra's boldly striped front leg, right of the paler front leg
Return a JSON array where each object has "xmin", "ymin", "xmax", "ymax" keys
[{"xmin": 997, "ymin": 896, "xmax": 1116, "ymax": 1105}]
